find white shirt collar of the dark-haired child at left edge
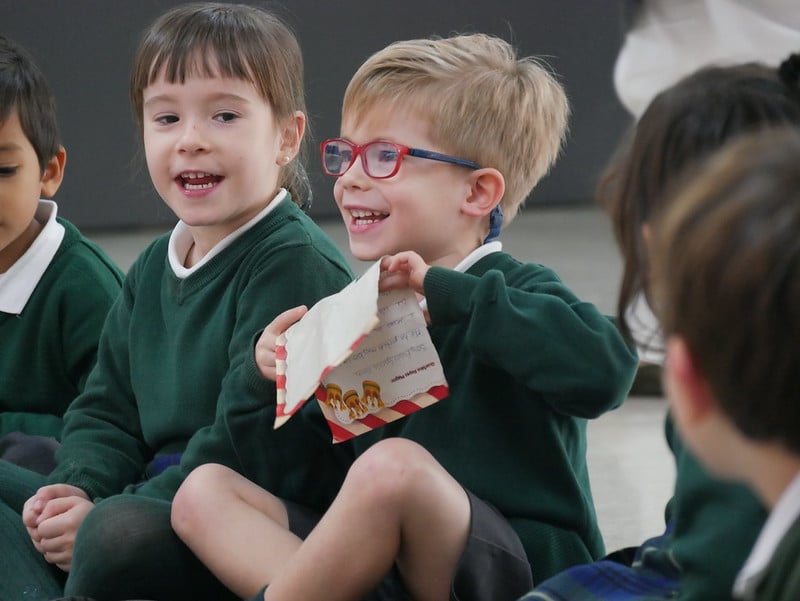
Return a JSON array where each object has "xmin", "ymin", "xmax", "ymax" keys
[{"xmin": 0, "ymin": 200, "xmax": 65, "ymax": 315}]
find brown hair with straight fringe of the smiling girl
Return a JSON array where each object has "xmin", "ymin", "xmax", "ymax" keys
[{"xmin": 130, "ymin": 2, "xmax": 310, "ymax": 204}]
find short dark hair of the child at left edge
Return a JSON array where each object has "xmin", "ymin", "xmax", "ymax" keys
[{"xmin": 0, "ymin": 36, "xmax": 61, "ymax": 171}]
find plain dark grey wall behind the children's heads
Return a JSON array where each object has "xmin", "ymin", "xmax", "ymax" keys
[{"xmin": 0, "ymin": 0, "xmax": 628, "ymax": 229}]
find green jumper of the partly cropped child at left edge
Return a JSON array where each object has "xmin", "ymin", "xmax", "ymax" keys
[{"xmin": 0, "ymin": 217, "xmax": 123, "ymax": 439}]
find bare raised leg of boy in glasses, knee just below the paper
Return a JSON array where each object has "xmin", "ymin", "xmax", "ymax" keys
[{"xmin": 265, "ymin": 438, "xmax": 470, "ymax": 601}]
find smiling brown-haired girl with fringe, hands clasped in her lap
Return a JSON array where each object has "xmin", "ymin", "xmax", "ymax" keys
[{"xmin": 0, "ymin": 3, "xmax": 352, "ymax": 601}]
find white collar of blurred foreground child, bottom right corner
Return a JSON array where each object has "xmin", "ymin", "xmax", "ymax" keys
[{"xmin": 733, "ymin": 474, "xmax": 800, "ymax": 601}]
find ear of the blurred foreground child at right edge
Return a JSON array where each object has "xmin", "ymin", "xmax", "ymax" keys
[{"xmin": 664, "ymin": 335, "xmax": 719, "ymax": 427}]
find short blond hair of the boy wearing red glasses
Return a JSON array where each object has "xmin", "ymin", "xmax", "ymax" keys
[{"xmin": 342, "ymin": 34, "xmax": 569, "ymax": 223}]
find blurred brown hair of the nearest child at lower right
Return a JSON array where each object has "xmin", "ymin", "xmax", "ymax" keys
[{"xmin": 653, "ymin": 127, "xmax": 800, "ymax": 454}]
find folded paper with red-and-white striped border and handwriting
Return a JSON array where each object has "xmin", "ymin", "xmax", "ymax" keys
[{"xmin": 273, "ymin": 263, "xmax": 448, "ymax": 442}]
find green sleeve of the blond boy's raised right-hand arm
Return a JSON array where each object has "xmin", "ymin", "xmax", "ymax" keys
[{"xmin": 424, "ymin": 264, "xmax": 637, "ymax": 418}]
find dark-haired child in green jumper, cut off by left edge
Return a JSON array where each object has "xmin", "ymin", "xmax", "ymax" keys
[{"xmin": 0, "ymin": 36, "xmax": 122, "ymax": 474}]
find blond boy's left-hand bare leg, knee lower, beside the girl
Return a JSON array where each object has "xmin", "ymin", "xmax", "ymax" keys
[{"xmin": 172, "ymin": 464, "xmax": 301, "ymax": 598}]
